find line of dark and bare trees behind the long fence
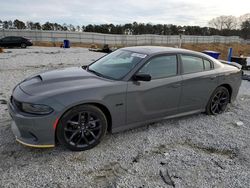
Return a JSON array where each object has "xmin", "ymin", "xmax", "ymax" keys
[{"xmin": 0, "ymin": 13, "xmax": 250, "ymax": 39}]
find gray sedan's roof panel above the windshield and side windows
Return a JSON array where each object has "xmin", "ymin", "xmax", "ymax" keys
[{"xmin": 123, "ymin": 46, "xmax": 200, "ymax": 55}]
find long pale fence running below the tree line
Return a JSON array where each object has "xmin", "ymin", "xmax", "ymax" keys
[{"xmin": 0, "ymin": 30, "xmax": 243, "ymax": 46}]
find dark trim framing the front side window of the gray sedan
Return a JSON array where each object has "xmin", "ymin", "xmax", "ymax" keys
[{"xmin": 131, "ymin": 53, "xmax": 181, "ymax": 80}]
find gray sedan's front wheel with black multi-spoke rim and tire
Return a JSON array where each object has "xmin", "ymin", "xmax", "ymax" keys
[{"xmin": 56, "ymin": 105, "xmax": 108, "ymax": 151}]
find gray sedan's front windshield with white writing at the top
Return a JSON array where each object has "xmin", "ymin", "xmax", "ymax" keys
[{"xmin": 87, "ymin": 50, "xmax": 146, "ymax": 80}]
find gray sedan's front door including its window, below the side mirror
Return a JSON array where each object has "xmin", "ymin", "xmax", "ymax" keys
[{"xmin": 126, "ymin": 54, "xmax": 182, "ymax": 124}]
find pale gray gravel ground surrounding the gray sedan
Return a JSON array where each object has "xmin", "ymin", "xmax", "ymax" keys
[{"xmin": 0, "ymin": 47, "xmax": 250, "ymax": 188}]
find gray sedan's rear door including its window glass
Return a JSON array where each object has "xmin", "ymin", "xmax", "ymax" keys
[{"xmin": 179, "ymin": 54, "xmax": 218, "ymax": 113}]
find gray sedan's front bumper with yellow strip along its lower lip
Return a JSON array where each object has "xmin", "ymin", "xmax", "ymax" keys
[{"xmin": 8, "ymin": 90, "xmax": 57, "ymax": 148}]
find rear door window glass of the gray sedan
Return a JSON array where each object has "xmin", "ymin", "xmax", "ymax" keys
[{"xmin": 181, "ymin": 55, "xmax": 203, "ymax": 74}]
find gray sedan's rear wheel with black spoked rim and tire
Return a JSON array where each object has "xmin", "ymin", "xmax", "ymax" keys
[{"xmin": 206, "ymin": 86, "xmax": 230, "ymax": 115}]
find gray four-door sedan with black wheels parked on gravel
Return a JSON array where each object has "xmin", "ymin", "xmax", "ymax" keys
[{"xmin": 8, "ymin": 46, "xmax": 241, "ymax": 151}]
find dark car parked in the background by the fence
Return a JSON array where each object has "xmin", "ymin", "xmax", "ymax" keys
[{"xmin": 0, "ymin": 36, "xmax": 33, "ymax": 48}]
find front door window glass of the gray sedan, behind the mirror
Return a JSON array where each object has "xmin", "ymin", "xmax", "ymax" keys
[{"xmin": 139, "ymin": 55, "xmax": 177, "ymax": 79}]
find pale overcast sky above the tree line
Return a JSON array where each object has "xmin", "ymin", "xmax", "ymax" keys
[{"xmin": 0, "ymin": 0, "xmax": 250, "ymax": 26}]
